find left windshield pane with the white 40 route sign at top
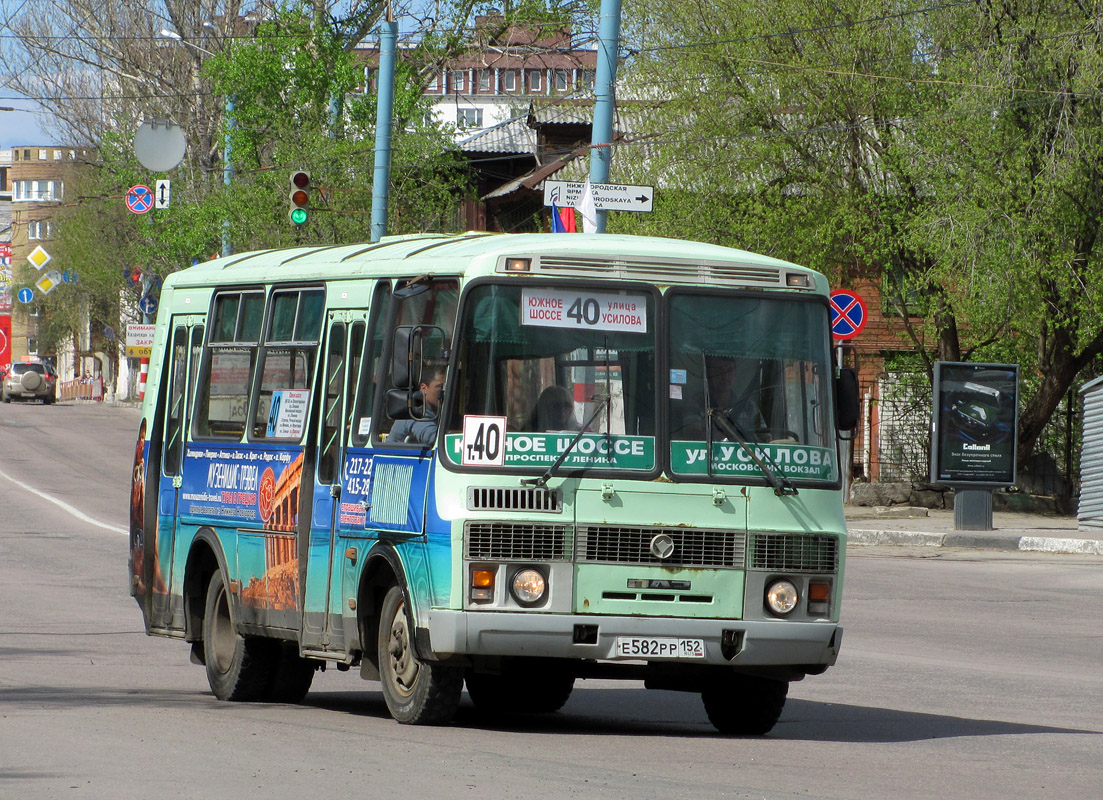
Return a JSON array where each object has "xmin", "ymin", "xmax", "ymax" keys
[{"xmin": 446, "ymin": 282, "xmax": 657, "ymax": 471}]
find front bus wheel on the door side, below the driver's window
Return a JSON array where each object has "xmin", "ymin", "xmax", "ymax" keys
[{"xmin": 376, "ymin": 586, "xmax": 463, "ymax": 725}]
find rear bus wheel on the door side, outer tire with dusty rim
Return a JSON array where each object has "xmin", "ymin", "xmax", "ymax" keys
[{"xmin": 203, "ymin": 569, "xmax": 276, "ymax": 701}]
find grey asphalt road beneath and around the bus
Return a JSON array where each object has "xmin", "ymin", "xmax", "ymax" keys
[{"xmin": 0, "ymin": 404, "xmax": 1103, "ymax": 800}]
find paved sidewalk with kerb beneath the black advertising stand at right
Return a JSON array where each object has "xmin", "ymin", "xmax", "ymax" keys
[{"xmin": 846, "ymin": 505, "xmax": 1103, "ymax": 556}]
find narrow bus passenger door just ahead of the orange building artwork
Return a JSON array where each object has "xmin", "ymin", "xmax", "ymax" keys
[{"xmin": 302, "ymin": 310, "xmax": 367, "ymax": 652}]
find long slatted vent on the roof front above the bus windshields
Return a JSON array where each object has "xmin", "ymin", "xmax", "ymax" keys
[{"xmin": 534, "ymin": 256, "xmax": 784, "ymax": 286}]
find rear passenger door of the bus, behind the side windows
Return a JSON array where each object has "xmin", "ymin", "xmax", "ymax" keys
[{"xmin": 152, "ymin": 317, "xmax": 203, "ymax": 630}]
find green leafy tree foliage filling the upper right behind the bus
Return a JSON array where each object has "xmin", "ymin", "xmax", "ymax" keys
[{"xmin": 611, "ymin": 0, "xmax": 1103, "ymax": 467}]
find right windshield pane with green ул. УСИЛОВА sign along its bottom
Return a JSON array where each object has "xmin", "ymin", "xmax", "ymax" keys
[{"xmin": 667, "ymin": 291, "xmax": 838, "ymax": 481}]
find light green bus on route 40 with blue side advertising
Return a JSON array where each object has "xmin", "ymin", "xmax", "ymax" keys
[{"xmin": 130, "ymin": 233, "xmax": 857, "ymax": 734}]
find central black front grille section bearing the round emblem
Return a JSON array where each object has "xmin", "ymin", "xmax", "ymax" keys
[{"xmin": 575, "ymin": 525, "xmax": 747, "ymax": 568}]
